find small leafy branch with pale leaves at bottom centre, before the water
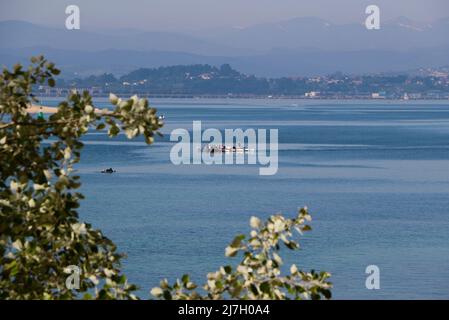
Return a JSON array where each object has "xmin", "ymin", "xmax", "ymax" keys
[{"xmin": 151, "ymin": 208, "xmax": 331, "ymax": 300}]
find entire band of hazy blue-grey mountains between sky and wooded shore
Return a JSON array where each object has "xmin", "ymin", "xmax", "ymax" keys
[{"xmin": 0, "ymin": 18, "xmax": 449, "ymax": 78}]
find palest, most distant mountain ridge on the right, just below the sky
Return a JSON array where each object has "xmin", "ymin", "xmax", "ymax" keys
[{"xmin": 192, "ymin": 17, "xmax": 449, "ymax": 52}]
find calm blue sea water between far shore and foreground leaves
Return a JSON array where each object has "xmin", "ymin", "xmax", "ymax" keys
[{"xmin": 44, "ymin": 100, "xmax": 449, "ymax": 299}]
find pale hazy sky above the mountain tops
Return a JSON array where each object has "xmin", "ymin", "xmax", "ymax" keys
[{"xmin": 0, "ymin": 0, "xmax": 449, "ymax": 31}]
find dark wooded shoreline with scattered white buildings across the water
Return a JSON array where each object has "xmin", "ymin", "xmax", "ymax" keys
[{"xmin": 35, "ymin": 64, "xmax": 449, "ymax": 100}]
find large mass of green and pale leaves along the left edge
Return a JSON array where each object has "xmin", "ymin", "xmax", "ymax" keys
[{"xmin": 0, "ymin": 57, "xmax": 163, "ymax": 299}]
